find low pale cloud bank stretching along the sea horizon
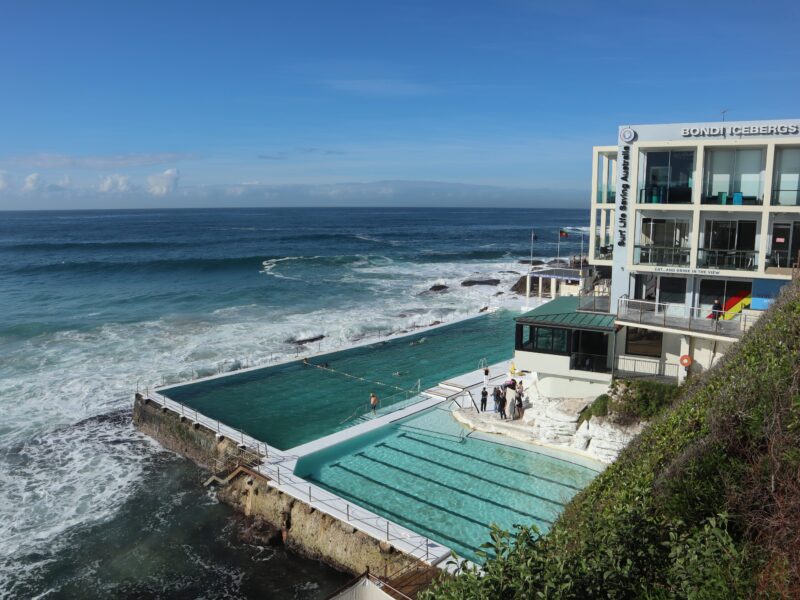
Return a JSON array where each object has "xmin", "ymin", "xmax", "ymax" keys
[{"xmin": 0, "ymin": 178, "xmax": 588, "ymax": 210}]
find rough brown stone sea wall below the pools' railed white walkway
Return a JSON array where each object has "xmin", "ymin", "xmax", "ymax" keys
[{"xmin": 133, "ymin": 395, "xmax": 429, "ymax": 576}]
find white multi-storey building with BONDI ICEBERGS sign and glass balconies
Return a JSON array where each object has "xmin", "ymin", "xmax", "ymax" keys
[{"xmin": 516, "ymin": 120, "xmax": 800, "ymax": 386}]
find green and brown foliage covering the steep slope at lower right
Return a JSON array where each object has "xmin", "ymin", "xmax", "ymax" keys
[{"xmin": 426, "ymin": 283, "xmax": 800, "ymax": 600}]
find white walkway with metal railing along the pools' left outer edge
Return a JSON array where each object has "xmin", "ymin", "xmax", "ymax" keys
[{"xmin": 144, "ymin": 390, "xmax": 450, "ymax": 565}]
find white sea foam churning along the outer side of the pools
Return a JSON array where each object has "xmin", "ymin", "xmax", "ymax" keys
[{"xmin": 0, "ymin": 252, "xmax": 525, "ymax": 597}]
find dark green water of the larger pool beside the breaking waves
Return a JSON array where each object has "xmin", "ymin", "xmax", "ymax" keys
[{"xmin": 162, "ymin": 311, "xmax": 514, "ymax": 450}]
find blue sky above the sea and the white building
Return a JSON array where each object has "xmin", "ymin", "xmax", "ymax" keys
[{"xmin": 0, "ymin": 0, "xmax": 800, "ymax": 208}]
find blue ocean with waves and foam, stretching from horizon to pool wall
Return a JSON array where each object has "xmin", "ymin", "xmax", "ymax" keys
[{"xmin": 0, "ymin": 208, "xmax": 589, "ymax": 598}]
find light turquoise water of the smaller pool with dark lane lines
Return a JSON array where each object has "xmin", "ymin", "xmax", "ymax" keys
[{"xmin": 295, "ymin": 407, "xmax": 597, "ymax": 562}]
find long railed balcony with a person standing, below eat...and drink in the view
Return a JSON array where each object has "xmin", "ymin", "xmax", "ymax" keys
[{"xmin": 617, "ymin": 298, "xmax": 761, "ymax": 338}]
